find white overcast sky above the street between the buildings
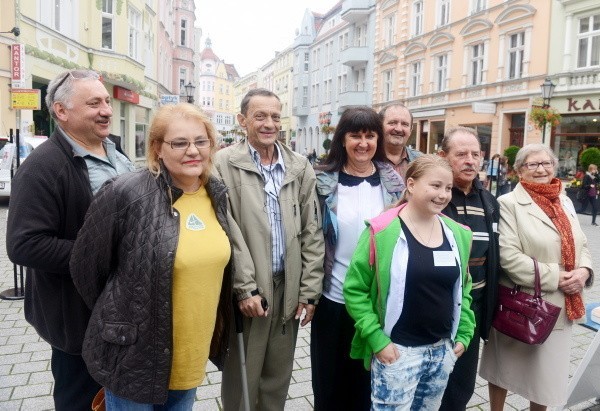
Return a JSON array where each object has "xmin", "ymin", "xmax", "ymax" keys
[{"xmin": 195, "ymin": 0, "xmax": 337, "ymax": 77}]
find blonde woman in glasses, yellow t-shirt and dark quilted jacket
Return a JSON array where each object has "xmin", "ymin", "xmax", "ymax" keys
[{"xmin": 70, "ymin": 103, "xmax": 252, "ymax": 410}]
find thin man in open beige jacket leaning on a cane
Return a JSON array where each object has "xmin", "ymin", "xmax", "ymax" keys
[{"xmin": 215, "ymin": 89, "xmax": 325, "ymax": 411}]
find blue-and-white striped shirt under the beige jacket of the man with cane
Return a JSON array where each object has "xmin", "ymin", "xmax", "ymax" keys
[{"xmin": 248, "ymin": 144, "xmax": 285, "ymax": 274}]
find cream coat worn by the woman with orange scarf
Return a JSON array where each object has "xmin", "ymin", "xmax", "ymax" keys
[{"xmin": 498, "ymin": 184, "xmax": 593, "ymax": 329}]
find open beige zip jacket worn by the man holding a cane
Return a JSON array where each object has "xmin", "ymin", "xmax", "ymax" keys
[{"xmin": 214, "ymin": 140, "xmax": 325, "ymax": 321}]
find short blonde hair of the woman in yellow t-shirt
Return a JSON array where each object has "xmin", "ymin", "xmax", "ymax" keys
[{"xmin": 146, "ymin": 103, "xmax": 217, "ymax": 185}]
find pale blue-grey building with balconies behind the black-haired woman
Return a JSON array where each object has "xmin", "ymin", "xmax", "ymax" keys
[{"xmin": 292, "ymin": 0, "xmax": 375, "ymax": 154}]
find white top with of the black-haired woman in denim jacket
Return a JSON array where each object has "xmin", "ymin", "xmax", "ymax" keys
[{"xmin": 323, "ymin": 181, "xmax": 384, "ymax": 304}]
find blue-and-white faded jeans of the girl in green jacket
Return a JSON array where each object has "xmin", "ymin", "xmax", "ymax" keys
[{"xmin": 371, "ymin": 338, "xmax": 456, "ymax": 411}]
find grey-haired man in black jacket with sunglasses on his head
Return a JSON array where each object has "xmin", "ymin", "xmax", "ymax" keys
[{"xmin": 6, "ymin": 70, "xmax": 134, "ymax": 411}]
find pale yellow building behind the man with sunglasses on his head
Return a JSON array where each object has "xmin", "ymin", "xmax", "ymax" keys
[{"xmin": 2, "ymin": 0, "xmax": 158, "ymax": 162}]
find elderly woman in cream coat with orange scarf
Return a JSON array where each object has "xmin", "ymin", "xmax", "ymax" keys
[{"xmin": 479, "ymin": 144, "xmax": 593, "ymax": 410}]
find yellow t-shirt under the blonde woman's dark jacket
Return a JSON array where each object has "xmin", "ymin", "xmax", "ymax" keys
[{"xmin": 169, "ymin": 187, "xmax": 231, "ymax": 390}]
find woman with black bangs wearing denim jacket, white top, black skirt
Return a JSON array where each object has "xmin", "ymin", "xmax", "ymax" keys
[{"xmin": 310, "ymin": 107, "xmax": 404, "ymax": 411}]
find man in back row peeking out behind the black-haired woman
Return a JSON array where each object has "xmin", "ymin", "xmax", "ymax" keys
[{"xmin": 379, "ymin": 103, "xmax": 423, "ymax": 179}]
